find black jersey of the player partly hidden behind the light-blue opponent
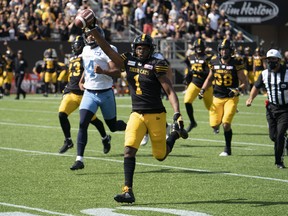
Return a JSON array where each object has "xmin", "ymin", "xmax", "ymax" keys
[{"xmin": 64, "ymin": 56, "xmax": 84, "ymax": 95}]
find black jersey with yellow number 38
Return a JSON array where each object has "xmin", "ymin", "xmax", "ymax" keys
[{"xmin": 209, "ymin": 56, "xmax": 245, "ymax": 98}]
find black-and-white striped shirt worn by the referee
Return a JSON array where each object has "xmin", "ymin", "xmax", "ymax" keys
[{"xmin": 254, "ymin": 65, "xmax": 288, "ymax": 105}]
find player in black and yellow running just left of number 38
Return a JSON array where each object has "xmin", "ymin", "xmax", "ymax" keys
[{"xmin": 184, "ymin": 38, "xmax": 213, "ymax": 132}]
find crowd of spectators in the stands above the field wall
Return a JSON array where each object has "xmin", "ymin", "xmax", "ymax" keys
[{"xmin": 0, "ymin": 0, "xmax": 244, "ymax": 42}]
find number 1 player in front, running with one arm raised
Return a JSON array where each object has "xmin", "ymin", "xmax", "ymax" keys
[{"xmin": 89, "ymin": 24, "xmax": 188, "ymax": 203}]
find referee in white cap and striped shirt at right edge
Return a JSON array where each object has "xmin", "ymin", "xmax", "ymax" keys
[{"xmin": 246, "ymin": 49, "xmax": 288, "ymax": 169}]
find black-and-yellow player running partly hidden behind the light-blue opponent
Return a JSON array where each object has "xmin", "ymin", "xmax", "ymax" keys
[{"xmin": 58, "ymin": 36, "xmax": 111, "ymax": 157}]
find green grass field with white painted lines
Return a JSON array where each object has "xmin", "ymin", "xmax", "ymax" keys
[{"xmin": 0, "ymin": 93, "xmax": 288, "ymax": 216}]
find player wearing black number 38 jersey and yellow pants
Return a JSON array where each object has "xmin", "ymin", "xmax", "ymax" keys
[{"xmin": 198, "ymin": 39, "xmax": 247, "ymax": 156}]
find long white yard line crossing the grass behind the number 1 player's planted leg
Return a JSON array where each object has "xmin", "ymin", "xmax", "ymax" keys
[{"xmin": 0, "ymin": 147, "xmax": 288, "ymax": 183}]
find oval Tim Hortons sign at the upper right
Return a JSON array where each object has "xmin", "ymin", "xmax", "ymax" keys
[{"xmin": 219, "ymin": 0, "xmax": 279, "ymax": 23}]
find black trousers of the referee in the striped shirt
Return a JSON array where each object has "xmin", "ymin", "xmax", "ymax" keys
[{"xmin": 266, "ymin": 103, "xmax": 288, "ymax": 164}]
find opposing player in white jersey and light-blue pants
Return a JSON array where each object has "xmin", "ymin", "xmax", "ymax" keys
[{"xmin": 70, "ymin": 26, "xmax": 126, "ymax": 170}]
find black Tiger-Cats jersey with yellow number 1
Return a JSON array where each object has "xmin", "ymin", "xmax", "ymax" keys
[{"xmin": 121, "ymin": 53, "xmax": 168, "ymax": 113}]
